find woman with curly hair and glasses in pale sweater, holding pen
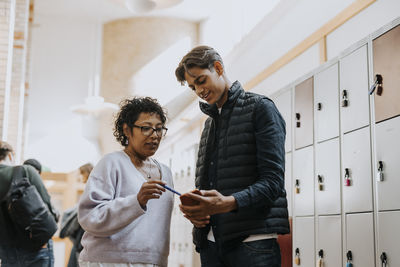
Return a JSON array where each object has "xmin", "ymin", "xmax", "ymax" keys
[{"xmin": 78, "ymin": 97, "xmax": 174, "ymax": 267}]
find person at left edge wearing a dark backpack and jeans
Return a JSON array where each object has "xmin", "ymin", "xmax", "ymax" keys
[{"xmin": 0, "ymin": 141, "xmax": 55, "ymax": 267}]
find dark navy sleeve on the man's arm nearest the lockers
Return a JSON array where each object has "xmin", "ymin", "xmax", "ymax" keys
[{"xmin": 233, "ymin": 98, "xmax": 286, "ymax": 209}]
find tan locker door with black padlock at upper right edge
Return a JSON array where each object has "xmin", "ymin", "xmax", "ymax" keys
[{"xmin": 372, "ymin": 26, "xmax": 400, "ymax": 122}]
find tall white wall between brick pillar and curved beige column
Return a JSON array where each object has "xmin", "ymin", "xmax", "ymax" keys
[{"xmin": 25, "ymin": 14, "xmax": 100, "ymax": 172}]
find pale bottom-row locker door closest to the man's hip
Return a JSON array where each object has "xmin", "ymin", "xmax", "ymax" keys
[{"xmin": 293, "ymin": 217, "xmax": 315, "ymax": 267}]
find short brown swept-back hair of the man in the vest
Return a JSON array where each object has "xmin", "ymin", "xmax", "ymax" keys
[{"xmin": 175, "ymin": 45, "xmax": 224, "ymax": 85}]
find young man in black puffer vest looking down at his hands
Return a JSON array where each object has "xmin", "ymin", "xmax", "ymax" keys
[{"xmin": 175, "ymin": 46, "xmax": 289, "ymax": 267}]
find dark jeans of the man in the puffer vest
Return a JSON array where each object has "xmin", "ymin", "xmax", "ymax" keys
[{"xmin": 200, "ymin": 238, "xmax": 281, "ymax": 267}]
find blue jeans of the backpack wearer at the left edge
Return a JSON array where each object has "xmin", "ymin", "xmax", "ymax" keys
[{"xmin": 0, "ymin": 240, "xmax": 54, "ymax": 267}]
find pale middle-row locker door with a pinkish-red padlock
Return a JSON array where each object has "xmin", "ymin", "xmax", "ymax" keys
[{"xmin": 342, "ymin": 127, "xmax": 372, "ymax": 212}]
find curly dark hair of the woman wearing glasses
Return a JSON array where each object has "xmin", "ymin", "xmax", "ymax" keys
[{"xmin": 114, "ymin": 97, "xmax": 167, "ymax": 146}]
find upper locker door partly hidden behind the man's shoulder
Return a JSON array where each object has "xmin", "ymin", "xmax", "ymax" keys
[{"xmin": 274, "ymin": 90, "xmax": 292, "ymax": 152}]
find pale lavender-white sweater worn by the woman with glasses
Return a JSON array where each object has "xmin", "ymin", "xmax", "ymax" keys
[{"xmin": 78, "ymin": 151, "xmax": 174, "ymax": 266}]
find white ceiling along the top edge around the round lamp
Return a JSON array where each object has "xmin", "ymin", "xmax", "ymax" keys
[{"xmin": 34, "ymin": 0, "xmax": 230, "ymax": 21}]
